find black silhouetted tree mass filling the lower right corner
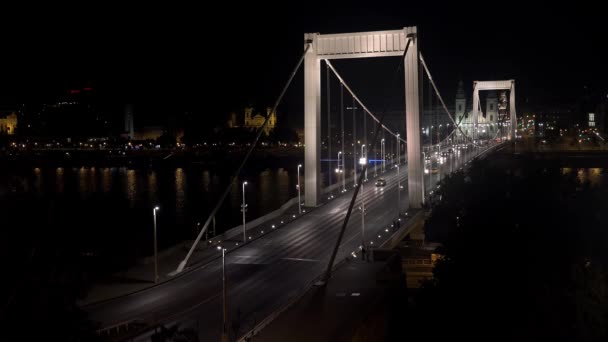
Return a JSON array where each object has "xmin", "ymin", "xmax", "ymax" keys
[{"xmin": 412, "ymin": 156, "xmax": 608, "ymax": 341}]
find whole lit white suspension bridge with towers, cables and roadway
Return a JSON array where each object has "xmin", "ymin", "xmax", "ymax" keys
[{"xmin": 85, "ymin": 27, "xmax": 516, "ymax": 340}]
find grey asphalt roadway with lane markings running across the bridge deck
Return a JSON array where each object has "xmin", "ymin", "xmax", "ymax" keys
[{"xmin": 86, "ymin": 143, "xmax": 490, "ymax": 341}]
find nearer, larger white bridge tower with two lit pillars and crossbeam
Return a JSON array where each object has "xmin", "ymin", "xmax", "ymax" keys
[{"xmin": 304, "ymin": 26, "xmax": 424, "ymax": 208}]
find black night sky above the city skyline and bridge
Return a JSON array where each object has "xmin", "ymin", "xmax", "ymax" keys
[{"xmin": 0, "ymin": 1, "xmax": 608, "ymax": 127}]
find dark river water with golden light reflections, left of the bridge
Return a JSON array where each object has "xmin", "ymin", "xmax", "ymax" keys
[{"xmin": 0, "ymin": 157, "xmax": 324, "ymax": 271}]
